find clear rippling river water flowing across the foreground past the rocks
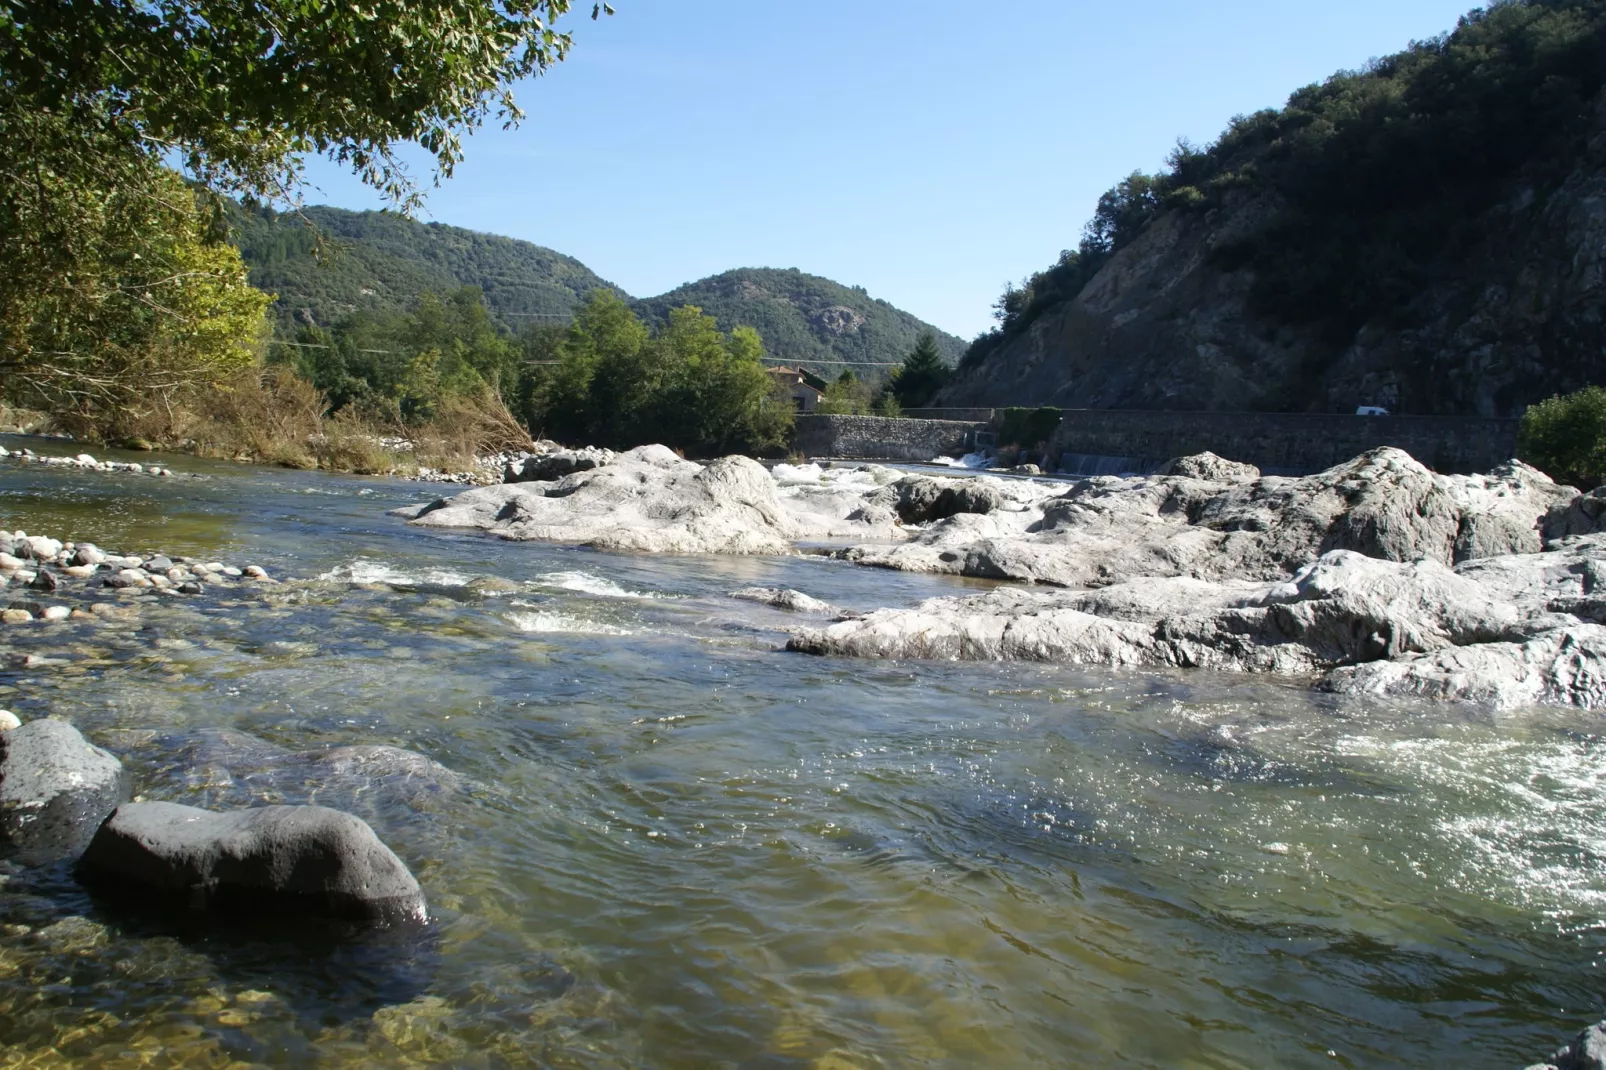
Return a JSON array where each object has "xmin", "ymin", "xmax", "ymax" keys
[{"xmin": 0, "ymin": 436, "xmax": 1606, "ymax": 1070}]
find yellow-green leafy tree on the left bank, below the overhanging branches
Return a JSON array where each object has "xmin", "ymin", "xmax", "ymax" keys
[{"xmin": 0, "ymin": 108, "xmax": 268, "ymax": 435}]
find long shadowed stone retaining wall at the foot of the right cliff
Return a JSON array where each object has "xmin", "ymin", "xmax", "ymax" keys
[{"xmin": 1047, "ymin": 408, "xmax": 1518, "ymax": 472}]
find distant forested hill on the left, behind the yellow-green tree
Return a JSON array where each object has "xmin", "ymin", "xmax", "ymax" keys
[{"xmin": 231, "ymin": 206, "xmax": 623, "ymax": 329}]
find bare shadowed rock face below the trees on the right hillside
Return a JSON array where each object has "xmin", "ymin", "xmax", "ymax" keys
[{"xmin": 936, "ymin": 98, "xmax": 1606, "ymax": 416}]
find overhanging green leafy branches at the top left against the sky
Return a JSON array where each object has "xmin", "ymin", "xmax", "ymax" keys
[{"xmin": 0, "ymin": 0, "xmax": 612, "ymax": 207}]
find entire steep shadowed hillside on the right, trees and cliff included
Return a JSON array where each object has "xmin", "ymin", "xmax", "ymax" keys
[{"xmin": 940, "ymin": 0, "xmax": 1606, "ymax": 416}]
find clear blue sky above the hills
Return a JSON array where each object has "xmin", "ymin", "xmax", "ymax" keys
[{"xmin": 307, "ymin": 0, "xmax": 1469, "ymax": 337}]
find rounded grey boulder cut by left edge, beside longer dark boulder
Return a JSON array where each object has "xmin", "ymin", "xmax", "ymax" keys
[{"xmin": 0, "ymin": 720, "xmax": 128, "ymax": 861}]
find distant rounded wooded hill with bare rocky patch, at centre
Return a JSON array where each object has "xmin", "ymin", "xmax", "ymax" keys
[{"xmin": 636, "ymin": 268, "xmax": 965, "ymax": 371}]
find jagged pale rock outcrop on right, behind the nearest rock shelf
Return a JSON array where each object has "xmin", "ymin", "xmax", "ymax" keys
[{"xmin": 846, "ymin": 448, "xmax": 1584, "ymax": 586}]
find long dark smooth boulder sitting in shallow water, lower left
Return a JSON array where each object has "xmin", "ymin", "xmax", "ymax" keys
[{"xmin": 79, "ymin": 802, "xmax": 427, "ymax": 924}]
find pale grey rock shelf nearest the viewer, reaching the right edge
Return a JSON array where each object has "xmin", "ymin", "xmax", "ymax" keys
[{"xmin": 789, "ymin": 537, "xmax": 1606, "ymax": 709}]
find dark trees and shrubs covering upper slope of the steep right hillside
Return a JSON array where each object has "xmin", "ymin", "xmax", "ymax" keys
[{"xmin": 962, "ymin": 0, "xmax": 1606, "ymax": 370}]
